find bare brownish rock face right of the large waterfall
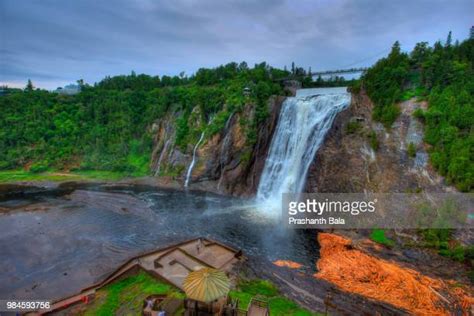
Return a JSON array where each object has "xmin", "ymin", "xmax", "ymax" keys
[{"xmin": 306, "ymin": 92, "xmax": 453, "ymax": 193}]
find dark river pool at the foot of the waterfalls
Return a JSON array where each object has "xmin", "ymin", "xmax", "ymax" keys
[{"xmin": 0, "ymin": 184, "xmax": 318, "ymax": 299}]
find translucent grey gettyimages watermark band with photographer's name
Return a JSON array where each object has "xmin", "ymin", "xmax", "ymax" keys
[{"xmin": 282, "ymin": 193, "xmax": 474, "ymax": 229}]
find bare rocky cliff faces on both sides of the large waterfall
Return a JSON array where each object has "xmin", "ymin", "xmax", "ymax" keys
[{"xmin": 152, "ymin": 92, "xmax": 453, "ymax": 196}]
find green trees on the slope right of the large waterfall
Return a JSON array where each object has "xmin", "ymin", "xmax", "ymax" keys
[{"xmin": 360, "ymin": 33, "xmax": 474, "ymax": 191}]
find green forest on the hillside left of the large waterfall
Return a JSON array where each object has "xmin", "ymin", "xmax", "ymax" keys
[{"xmin": 0, "ymin": 62, "xmax": 289, "ymax": 175}]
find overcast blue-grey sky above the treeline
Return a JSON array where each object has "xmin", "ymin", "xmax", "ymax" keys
[{"xmin": 0, "ymin": 0, "xmax": 474, "ymax": 89}]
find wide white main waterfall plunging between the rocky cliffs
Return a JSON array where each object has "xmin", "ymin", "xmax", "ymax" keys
[{"xmin": 257, "ymin": 88, "xmax": 351, "ymax": 205}]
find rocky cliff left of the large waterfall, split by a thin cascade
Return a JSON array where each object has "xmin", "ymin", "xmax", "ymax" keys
[{"xmin": 151, "ymin": 97, "xmax": 285, "ymax": 196}]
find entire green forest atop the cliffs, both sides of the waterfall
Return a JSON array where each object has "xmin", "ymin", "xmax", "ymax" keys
[{"xmin": 0, "ymin": 34, "xmax": 474, "ymax": 191}]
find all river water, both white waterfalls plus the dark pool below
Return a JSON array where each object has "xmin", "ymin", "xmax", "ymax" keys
[{"xmin": 0, "ymin": 88, "xmax": 350, "ymax": 299}]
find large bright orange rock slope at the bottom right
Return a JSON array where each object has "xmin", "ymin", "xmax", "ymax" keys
[{"xmin": 315, "ymin": 233, "xmax": 472, "ymax": 315}]
